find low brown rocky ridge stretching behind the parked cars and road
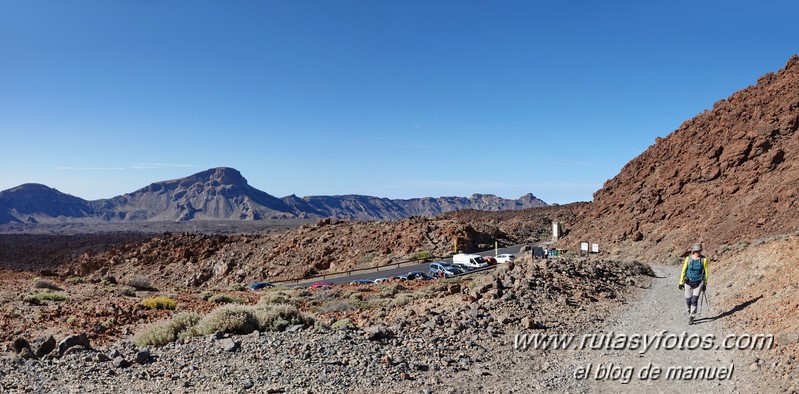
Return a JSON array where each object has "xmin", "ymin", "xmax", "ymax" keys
[{"xmin": 0, "ymin": 204, "xmax": 579, "ymax": 288}]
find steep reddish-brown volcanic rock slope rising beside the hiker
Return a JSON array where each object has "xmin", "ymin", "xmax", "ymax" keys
[{"xmin": 561, "ymin": 56, "xmax": 799, "ymax": 261}]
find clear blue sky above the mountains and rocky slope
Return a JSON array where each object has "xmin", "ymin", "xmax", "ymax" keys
[{"xmin": 0, "ymin": 0, "xmax": 799, "ymax": 204}]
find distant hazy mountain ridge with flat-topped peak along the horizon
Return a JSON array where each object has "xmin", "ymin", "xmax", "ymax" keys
[{"xmin": 0, "ymin": 167, "xmax": 547, "ymax": 224}]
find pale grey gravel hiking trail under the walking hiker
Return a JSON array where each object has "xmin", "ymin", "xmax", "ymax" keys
[{"xmin": 542, "ymin": 265, "xmax": 773, "ymax": 394}]
